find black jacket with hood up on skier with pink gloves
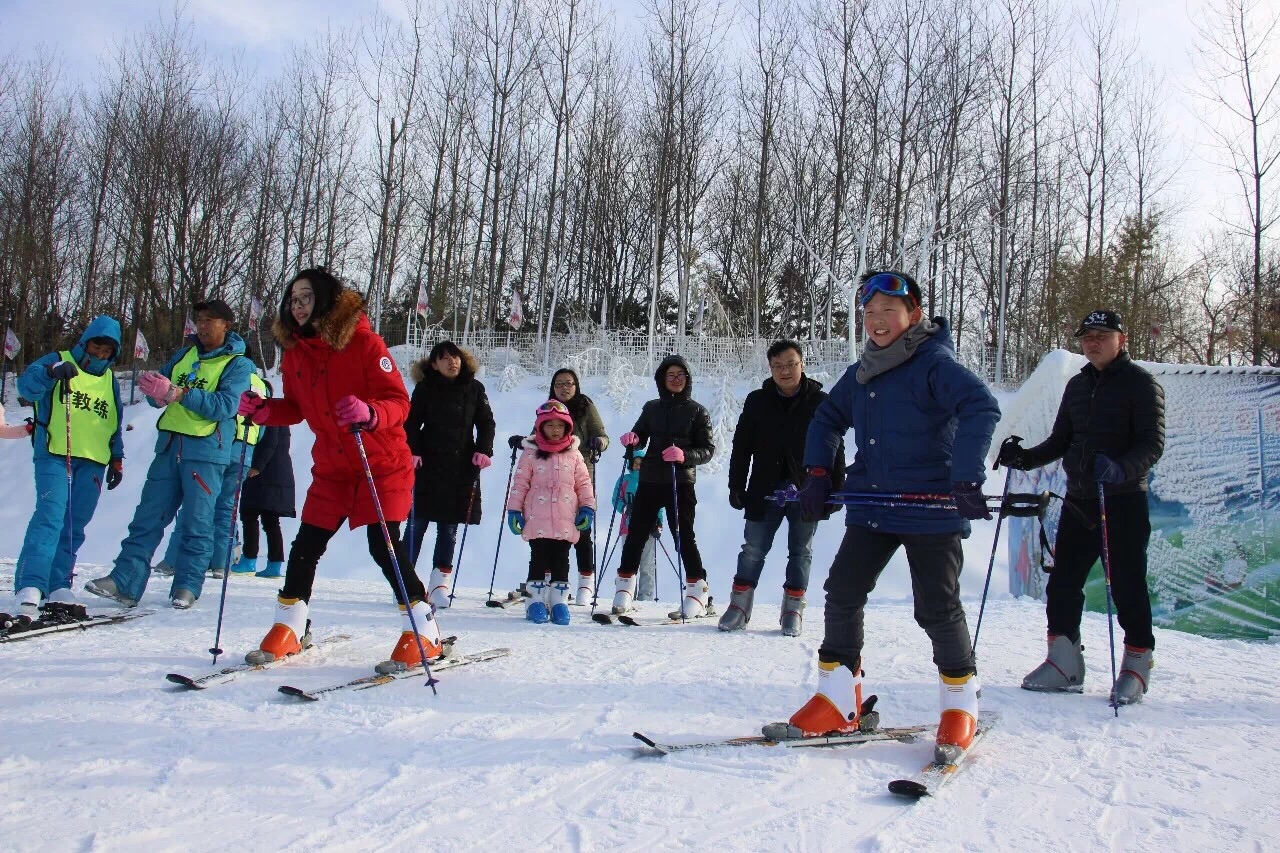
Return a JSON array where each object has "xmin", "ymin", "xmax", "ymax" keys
[{"xmin": 631, "ymin": 355, "xmax": 716, "ymax": 483}]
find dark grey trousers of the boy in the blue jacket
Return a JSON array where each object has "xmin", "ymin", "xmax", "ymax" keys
[{"xmin": 818, "ymin": 526, "xmax": 977, "ymax": 678}]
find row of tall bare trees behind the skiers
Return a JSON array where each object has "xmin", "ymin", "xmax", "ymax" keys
[{"xmin": 0, "ymin": 0, "xmax": 1280, "ymax": 374}]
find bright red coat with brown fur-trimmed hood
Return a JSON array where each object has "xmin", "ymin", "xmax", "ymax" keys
[{"xmin": 266, "ymin": 289, "xmax": 413, "ymax": 530}]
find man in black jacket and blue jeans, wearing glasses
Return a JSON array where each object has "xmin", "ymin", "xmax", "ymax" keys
[{"xmin": 719, "ymin": 341, "xmax": 845, "ymax": 637}]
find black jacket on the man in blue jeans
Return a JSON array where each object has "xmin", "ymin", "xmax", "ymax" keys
[{"xmin": 728, "ymin": 377, "xmax": 845, "ymax": 521}]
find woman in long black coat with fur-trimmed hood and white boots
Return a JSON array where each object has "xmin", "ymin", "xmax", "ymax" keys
[{"xmin": 404, "ymin": 341, "xmax": 495, "ymax": 607}]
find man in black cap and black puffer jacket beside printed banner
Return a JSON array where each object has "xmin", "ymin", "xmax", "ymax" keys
[{"xmin": 1000, "ymin": 311, "xmax": 1165, "ymax": 704}]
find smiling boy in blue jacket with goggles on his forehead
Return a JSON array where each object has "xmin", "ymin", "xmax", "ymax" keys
[{"xmin": 791, "ymin": 273, "xmax": 1000, "ymax": 761}]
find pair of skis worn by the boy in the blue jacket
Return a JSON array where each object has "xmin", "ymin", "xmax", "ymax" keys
[{"xmin": 632, "ymin": 717, "xmax": 996, "ymax": 800}]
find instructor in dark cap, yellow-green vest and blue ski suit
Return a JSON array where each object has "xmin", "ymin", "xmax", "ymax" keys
[{"xmin": 84, "ymin": 300, "xmax": 253, "ymax": 610}]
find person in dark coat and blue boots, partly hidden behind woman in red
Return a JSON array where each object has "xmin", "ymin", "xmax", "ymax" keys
[{"xmin": 232, "ymin": 383, "xmax": 297, "ymax": 578}]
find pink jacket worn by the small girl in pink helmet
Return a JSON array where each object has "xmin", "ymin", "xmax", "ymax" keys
[{"xmin": 507, "ymin": 435, "xmax": 595, "ymax": 542}]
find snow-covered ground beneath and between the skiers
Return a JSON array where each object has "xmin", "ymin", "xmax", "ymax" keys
[{"xmin": 0, "ymin": 368, "xmax": 1280, "ymax": 850}]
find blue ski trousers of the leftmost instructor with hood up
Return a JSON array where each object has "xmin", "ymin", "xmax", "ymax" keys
[{"xmin": 13, "ymin": 456, "xmax": 106, "ymax": 596}]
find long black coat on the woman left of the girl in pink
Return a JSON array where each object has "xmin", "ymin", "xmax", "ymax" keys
[{"xmin": 404, "ymin": 350, "xmax": 497, "ymax": 524}]
